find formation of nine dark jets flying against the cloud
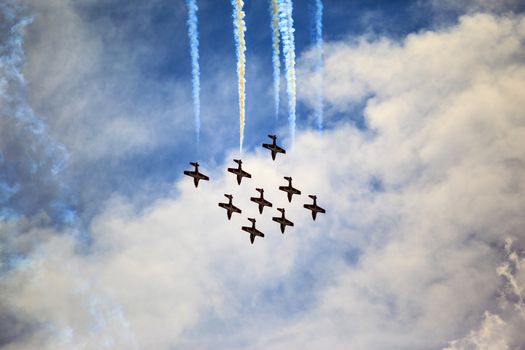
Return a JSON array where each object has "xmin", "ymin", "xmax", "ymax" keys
[{"xmin": 184, "ymin": 135, "xmax": 326, "ymax": 244}]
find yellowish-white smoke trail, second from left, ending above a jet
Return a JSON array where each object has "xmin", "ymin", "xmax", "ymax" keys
[{"xmin": 232, "ymin": 0, "xmax": 246, "ymax": 152}]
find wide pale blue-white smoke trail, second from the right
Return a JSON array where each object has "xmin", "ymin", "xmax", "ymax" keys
[{"xmin": 278, "ymin": 0, "xmax": 296, "ymax": 145}]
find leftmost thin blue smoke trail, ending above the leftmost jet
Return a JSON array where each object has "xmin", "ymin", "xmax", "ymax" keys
[{"xmin": 186, "ymin": 0, "xmax": 201, "ymax": 144}]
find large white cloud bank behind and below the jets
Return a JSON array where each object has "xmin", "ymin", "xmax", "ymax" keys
[{"xmin": 0, "ymin": 6, "xmax": 525, "ymax": 349}]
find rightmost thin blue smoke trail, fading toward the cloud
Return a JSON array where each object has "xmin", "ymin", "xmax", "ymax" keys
[{"xmin": 312, "ymin": 0, "xmax": 324, "ymax": 130}]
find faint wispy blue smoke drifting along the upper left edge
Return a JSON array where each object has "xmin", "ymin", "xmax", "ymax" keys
[{"xmin": 0, "ymin": 3, "xmax": 67, "ymax": 219}]
